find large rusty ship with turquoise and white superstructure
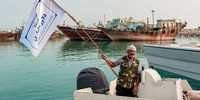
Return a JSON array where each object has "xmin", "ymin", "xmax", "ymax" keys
[{"xmin": 99, "ymin": 17, "xmax": 187, "ymax": 41}]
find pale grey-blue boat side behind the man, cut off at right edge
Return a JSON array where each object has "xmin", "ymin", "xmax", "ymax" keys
[{"xmin": 142, "ymin": 43, "xmax": 200, "ymax": 80}]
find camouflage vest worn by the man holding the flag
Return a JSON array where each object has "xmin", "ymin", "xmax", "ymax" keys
[{"xmin": 117, "ymin": 56, "xmax": 139, "ymax": 89}]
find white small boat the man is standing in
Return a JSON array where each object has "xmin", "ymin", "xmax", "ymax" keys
[{"xmin": 74, "ymin": 69, "xmax": 199, "ymax": 100}]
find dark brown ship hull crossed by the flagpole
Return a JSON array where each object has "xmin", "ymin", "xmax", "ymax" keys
[{"xmin": 57, "ymin": 25, "xmax": 111, "ymax": 41}]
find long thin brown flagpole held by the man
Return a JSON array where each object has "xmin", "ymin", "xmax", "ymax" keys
[{"xmin": 53, "ymin": 0, "xmax": 119, "ymax": 77}]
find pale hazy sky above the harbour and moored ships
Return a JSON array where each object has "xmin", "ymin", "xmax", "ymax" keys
[{"xmin": 0, "ymin": 0, "xmax": 200, "ymax": 30}]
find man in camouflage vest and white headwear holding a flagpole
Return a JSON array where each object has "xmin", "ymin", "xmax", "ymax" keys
[{"xmin": 102, "ymin": 45, "xmax": 141, "ymax": 97}]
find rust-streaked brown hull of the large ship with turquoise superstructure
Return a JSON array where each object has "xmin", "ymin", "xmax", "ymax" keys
[{"xmin": 100, "ymin": 24, "xmax": 183, "ymax": 41}]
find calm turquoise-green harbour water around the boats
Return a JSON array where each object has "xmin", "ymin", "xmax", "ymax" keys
[{"xmin": 0, "ymin": 38, "xmax": 200, "ymax": 100}]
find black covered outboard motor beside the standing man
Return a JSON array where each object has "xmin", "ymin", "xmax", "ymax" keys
[{"xmin": 77, "ymin": 67, "xmax": 109, "ymax": 94}]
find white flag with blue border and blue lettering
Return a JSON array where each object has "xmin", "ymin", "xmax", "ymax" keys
[{"xmin": 20, "ymin": 0, "xmax": 65, "ymax": 56}]
